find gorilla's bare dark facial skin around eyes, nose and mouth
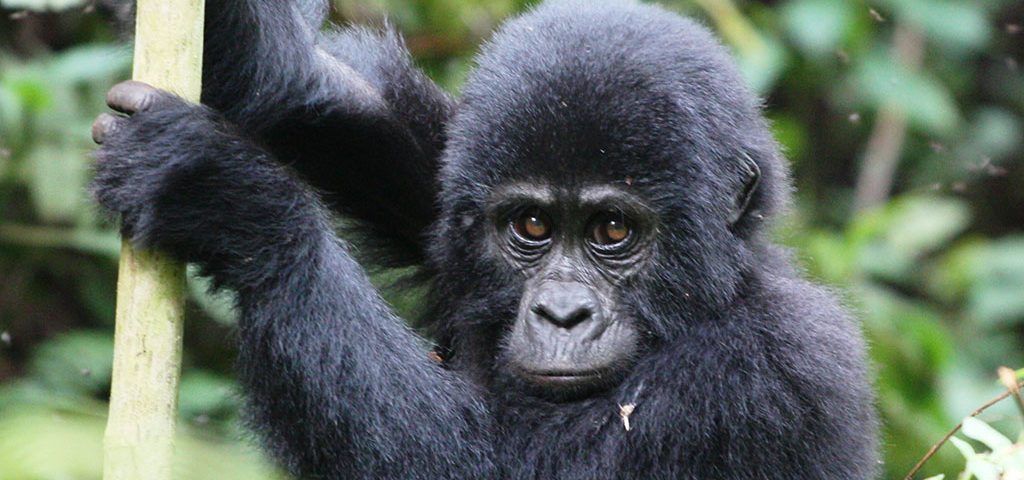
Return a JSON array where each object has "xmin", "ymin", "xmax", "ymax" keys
[{"xmin": 488, "ymin": 183, "xmax": 655, "ymax": 398}]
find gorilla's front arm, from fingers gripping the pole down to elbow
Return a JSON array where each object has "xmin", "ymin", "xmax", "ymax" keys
[{"xmin": 93, "ymin": 82, "xmax": 493, "ymax": 478}]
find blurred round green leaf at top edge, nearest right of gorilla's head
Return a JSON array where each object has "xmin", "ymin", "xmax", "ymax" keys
[{"xmin": 780, "ymin": 0, "xmax": 853, "ymax": 56}]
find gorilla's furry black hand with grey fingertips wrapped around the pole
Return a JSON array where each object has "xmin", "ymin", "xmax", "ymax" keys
[{"xmin": 91, "ymin": 81, "xmax": 327, "ymax": 276}]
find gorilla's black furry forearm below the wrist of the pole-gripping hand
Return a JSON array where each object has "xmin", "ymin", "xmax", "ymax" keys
[{"xmin": 239, "ymin": 238, "xmax": 494, "ymax": 478}]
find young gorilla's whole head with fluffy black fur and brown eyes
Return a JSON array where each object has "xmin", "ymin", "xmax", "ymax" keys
[{"xmin": 433, "ymin": 2, "xmax": 786, "ymax": 398}]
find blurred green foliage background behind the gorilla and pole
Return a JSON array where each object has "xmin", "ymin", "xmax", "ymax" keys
[{"xmin": 0, "ymin": 0, "xmax": 1024, "ymax": 480}]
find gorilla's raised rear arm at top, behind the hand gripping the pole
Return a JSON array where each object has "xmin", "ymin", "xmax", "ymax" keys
[{"xmin": 203, "ymin": 0, "xmax": 452, "ymax": 263}]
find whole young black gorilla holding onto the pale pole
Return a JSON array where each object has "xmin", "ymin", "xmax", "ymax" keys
[{"xmin": 93, "ymin": 0, "xmax": 876, "ymax": 479}]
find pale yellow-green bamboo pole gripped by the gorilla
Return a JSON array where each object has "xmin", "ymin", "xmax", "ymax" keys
[{"xmin": 103, "ymin": 0, "xmax": 204, "ymax": 480}]
